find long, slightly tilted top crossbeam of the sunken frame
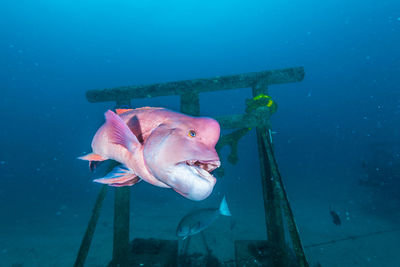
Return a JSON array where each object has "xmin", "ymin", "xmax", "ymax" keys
[{"xmin": 86, "ymin": 67, "xmax": 304, "ymax": 103}]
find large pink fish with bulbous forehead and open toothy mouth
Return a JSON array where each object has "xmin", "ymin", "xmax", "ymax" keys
[{"xmin": 80, "ymin": 107, "xmax": 221, "ymax": 201}]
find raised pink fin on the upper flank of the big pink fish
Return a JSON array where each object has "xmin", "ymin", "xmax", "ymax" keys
[{"xmin": 105, "ymin": 110, "xmax": 140, "ymax": 152}]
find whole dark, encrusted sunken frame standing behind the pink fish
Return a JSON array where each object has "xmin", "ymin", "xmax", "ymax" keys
[{"xmin": 74, "ymin": 67, "xmax": 308, "ymax": 266}]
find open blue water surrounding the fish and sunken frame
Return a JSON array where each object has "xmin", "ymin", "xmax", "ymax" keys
[{"xmin": 0, "ymin": 0, "xmax": 400, "ymax": 266}]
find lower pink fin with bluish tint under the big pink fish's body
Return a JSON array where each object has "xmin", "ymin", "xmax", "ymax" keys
[{"xmin": 93, "ymin": 166, "xmax": 142, "ymax": 186}]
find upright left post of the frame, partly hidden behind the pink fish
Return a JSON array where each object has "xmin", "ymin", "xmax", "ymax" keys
[{"xmin": 111, "ymin": 99, "xmax": 130, "ymax": 267}]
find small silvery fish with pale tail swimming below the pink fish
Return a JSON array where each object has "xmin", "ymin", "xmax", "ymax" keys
[{"xmin": 176, "ymin": 197, "xmax": 232, "ymax": 240}]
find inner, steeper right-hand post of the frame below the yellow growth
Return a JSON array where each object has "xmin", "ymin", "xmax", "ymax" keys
[{"xmin": 252, "ymin": 82, "xmax": 286, "ymax": 266}]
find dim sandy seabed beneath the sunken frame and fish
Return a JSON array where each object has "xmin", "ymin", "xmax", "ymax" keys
[{"xmin": 0, "ymin": 171, "xmax": 400, "ymax": 267}]
